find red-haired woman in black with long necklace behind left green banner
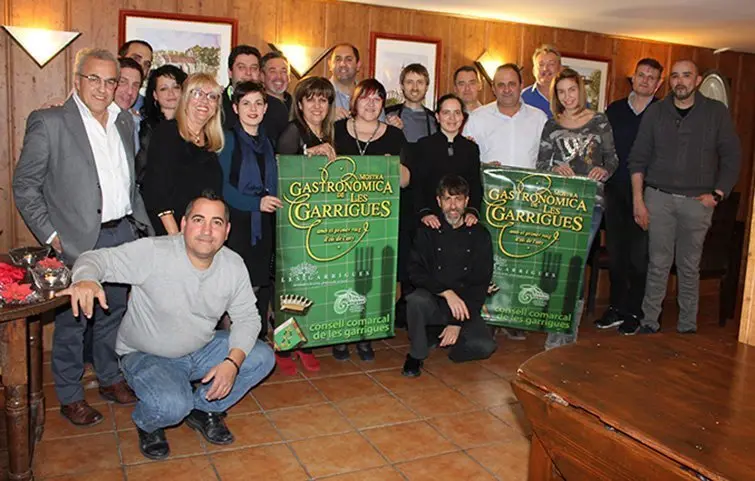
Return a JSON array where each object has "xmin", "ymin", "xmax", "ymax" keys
[{"xmin": 333, "ymin": 79, "xmax": 410, "ymax": 361}]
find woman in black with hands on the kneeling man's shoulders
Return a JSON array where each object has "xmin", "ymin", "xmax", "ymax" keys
[{"xmin": 412, "ymin": 94, "xmax": 482, "ymax": 229}]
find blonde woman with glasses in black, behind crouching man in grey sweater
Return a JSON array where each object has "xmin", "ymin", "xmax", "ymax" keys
[{"xmin": 142, "ymin": 73, "xmax": 224, "ymax": 235}]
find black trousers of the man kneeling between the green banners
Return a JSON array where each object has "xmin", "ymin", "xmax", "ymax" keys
[{"xmin": 406, "ymin": 288, "xmax": 498, "ymax": 362}]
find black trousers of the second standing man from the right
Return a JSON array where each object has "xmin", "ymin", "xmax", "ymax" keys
[{"xmin": 605, "ymin": 187, "xmax": 648, "ymax": 318}]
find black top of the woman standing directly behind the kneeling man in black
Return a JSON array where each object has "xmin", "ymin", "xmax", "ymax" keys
[{"xmin": 412, "ymin": 132, "xmax": 482, "ymax": 218}]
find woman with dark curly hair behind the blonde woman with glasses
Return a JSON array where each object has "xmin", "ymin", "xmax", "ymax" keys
[{"xmin": 136, "ymin": 64, "xmax": 186, "ymax": 184}]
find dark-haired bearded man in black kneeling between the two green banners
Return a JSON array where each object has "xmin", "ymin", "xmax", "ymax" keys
[{"xmin": 402, "ymin": 175, "xmax": 496, "ymax": 377}]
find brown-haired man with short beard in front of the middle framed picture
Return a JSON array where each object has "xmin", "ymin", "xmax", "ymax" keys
[{"xmin": 385, "ymin": 63, "xmax": 438, "ymax": 144}]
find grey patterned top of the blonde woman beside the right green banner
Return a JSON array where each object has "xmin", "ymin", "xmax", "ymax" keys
[{"xmin": 537, "ymin": 113, "xmax": 619, "ymax": 207}]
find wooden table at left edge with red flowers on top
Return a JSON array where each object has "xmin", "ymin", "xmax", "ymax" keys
[{"xmin": 0, "ymin": 297, "xmax": 68, "ymax": 481}]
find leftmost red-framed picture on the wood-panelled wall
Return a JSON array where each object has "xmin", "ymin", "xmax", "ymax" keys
[{"xmin": 118, "ymin": 10, "xmax": 238, "ymax": 86}]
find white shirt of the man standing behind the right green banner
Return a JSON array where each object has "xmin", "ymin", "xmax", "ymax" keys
[{"xmin": 464, "ymin": 102, "xmax": 548, "ymax": 169}]
